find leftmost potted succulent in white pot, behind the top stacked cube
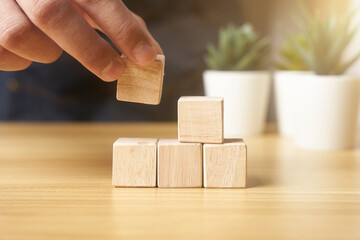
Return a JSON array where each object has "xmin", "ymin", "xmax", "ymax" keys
[{"xmin": 203, "ymin": 24, "xmax": 270, "ymax": 138}]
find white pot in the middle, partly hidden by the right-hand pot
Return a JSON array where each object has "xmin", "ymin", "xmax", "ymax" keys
[{"xmin": 274, "ymin": 71, "xmax": 313, "ymax": 137}]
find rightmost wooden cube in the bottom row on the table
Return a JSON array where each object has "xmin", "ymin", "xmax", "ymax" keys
[{"xmin": 204, "ymin": 139, "xmax": 247, "ymax": 188}]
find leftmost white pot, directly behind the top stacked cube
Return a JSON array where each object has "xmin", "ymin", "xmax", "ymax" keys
[{"xmin": 203, "ymin": 70, "xmax": 271, "ymax": 138}]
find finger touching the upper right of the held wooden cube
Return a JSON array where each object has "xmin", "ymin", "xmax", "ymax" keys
[{"xmin": 74, "ymin": 0, "xmax": 159, "ymax": 64}]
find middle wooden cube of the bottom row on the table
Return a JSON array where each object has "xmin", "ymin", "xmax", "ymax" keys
[{"xmin": 158, "ymin": 139, "xmax": 202, "ymax": 188}]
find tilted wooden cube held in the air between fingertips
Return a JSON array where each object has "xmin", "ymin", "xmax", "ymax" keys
[{"xmin": 116, "ymin": 55, "xmax": 165, "ymax": 105}]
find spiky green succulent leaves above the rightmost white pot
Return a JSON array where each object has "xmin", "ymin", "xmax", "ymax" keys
[{"xmin": 290, "ymin": 1, "xmax": 360, "ymax": 75}]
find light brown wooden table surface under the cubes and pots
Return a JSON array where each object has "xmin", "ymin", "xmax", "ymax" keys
[{"xmin": 0, "ymin": 123, "xmax": 360, "ymax": 240}]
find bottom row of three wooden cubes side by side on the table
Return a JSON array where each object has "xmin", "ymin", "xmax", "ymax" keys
[{"xmin": 113, "ymin": 138, "xmax": 247, "ymax": 188}]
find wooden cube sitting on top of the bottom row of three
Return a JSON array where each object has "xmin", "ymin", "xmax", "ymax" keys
[{"xmin": 178, "ymin": 97, "xmax": 224, "ymax": 143}]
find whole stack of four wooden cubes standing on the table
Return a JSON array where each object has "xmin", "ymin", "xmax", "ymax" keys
[{"xmin": 112, "ymin": 97, "xmax": 247, "ymax": 188}]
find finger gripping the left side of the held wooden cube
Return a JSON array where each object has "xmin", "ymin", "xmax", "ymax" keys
[{"xmin": 17, "ymin": 0, "xmax": 123, "ymax": 81}]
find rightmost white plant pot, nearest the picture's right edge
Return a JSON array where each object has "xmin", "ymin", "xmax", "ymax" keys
[{"xmin": 295, "ymin": 75, "xmax": 360, "ymax": 151}]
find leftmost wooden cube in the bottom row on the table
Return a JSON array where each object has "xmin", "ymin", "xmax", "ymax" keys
[{"xmin": 112, "ymin": 138, "xmax": 158, "ymax": 187}]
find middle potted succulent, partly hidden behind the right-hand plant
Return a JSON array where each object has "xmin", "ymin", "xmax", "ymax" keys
[{"xmin": 274, "ymin": 34, "xmax": 312, "ymax": 137}]
